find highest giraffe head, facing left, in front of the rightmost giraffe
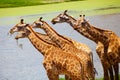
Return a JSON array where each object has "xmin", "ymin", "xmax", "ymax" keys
[{"xmin": 51, "ymin": 10, "xmax": 71, "ymax": 24}]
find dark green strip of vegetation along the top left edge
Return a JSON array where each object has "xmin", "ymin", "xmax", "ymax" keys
[{"xmin": 0, "ymin": 0, "xmax": 80, "ymax": 8}]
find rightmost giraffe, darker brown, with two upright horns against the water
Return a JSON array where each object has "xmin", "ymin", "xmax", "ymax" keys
[{"xmin": 76, "ymin": 15, "xmax": 120, "ymax": 80}]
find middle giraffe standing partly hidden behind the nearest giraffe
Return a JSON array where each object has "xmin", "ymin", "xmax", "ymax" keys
[{"xmin": 33, "ymin": 17, "xmax": 95, "ymax": 80}]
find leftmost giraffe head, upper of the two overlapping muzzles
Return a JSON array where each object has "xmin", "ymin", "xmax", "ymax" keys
[{"xmin": 9, "ymin": 19, "xmax": 26, "ymax": 34}]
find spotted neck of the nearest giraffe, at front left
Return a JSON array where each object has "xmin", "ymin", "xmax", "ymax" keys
[{"xmin": 28, "ymin": 27, "xmax": 54, "ymax": 55}]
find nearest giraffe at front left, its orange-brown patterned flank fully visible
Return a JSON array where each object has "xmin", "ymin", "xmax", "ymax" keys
[{"xmin": 8, "ymin": 21, "xmax": 84, "ymax": 80}]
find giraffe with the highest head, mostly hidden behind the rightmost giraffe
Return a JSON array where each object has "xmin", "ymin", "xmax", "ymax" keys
[{"xmin": 52, "ymin": 10, "xmax": 118, "ymax": 80}]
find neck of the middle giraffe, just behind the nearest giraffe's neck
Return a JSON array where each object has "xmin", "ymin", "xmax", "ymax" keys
[{"xmin": 43, "ymin": 22, "xmax": 73, "ymax": 47}]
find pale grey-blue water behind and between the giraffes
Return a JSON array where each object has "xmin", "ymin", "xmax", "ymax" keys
[{"xmin": 0, "ymin": 14, "xmax": 120, "ymax": 80}]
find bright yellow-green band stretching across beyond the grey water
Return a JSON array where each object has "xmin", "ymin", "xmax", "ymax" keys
[{"xmin": 0, "ymin": 0, "xmax": 120, "ymax": 17}]
